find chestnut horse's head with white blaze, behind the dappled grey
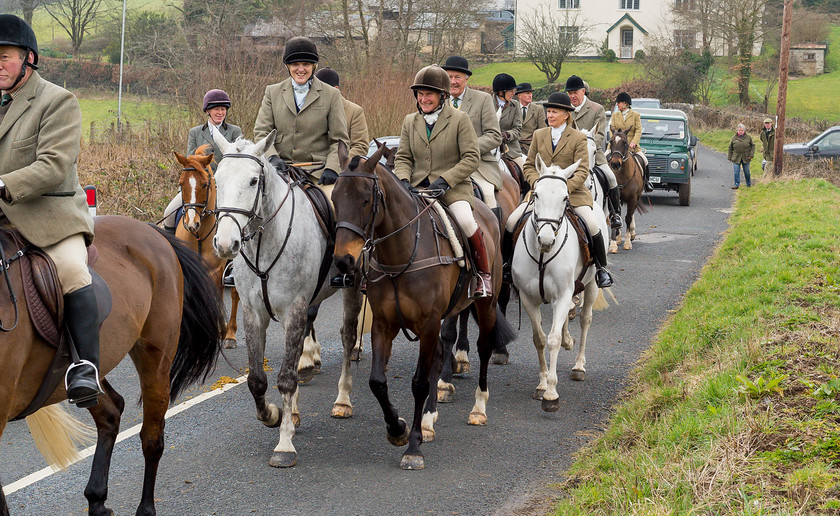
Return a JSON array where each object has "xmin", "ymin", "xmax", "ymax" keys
[{"xmin": 175, "ymin": 144, "xmax": 215, "ymax": 235}]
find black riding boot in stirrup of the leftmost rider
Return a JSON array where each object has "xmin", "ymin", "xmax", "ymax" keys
[{"xmin": 64, "ymin": 285, "xmax": 102, "ymax": 408}]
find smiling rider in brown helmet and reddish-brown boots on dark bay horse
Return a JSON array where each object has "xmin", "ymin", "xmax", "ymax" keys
[{"xmin": 394, "ymin": 65, "xmax": 493, "ymax": 297}]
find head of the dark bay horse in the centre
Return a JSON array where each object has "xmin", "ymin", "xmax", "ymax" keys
[{"xmin": 332, "ymin": 137, "xmax": 396, "ymax": 274}]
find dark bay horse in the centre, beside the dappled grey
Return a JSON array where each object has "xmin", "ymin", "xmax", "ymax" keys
[{"xmin": 332, "ymin": 140, "xmax": 514, "ymax": 469}]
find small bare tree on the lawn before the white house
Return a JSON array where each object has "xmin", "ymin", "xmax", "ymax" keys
[{"xmin": 517, "ymin": 6, "xmax": 592, "ymax": 82}]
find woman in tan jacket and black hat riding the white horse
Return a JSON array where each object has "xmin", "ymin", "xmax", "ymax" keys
[{"xmin": 505, "ymin": 92, "xmax": 612, "ymax": 288}]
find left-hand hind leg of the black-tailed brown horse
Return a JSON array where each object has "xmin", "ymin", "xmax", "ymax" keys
[{"xmin": 85, "ymin": 378, "xmax": 124, "ymax": 516}]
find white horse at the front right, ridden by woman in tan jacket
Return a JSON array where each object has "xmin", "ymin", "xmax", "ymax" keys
[{"xmin": 512, "ymin": 156, "xmax": 607, "ymax": 412}]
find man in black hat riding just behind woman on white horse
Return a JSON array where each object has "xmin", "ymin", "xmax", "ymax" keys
[{"xmin": 563, "ymin": 75, "xmax": 621, "ymax": 228}]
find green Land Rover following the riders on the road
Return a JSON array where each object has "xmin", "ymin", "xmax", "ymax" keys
[{"xmin": 636, "ymin": 108, "xmax": 697, "ymax": 206}]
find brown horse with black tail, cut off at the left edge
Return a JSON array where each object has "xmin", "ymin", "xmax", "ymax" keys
[{"xmin": 0, "ymin": 216, "xmax": 224, "ymax": 516}]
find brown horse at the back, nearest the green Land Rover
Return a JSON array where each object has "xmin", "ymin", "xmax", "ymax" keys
[{"xmin": 604, "ymin": 130, "xmax": 645, "ymax": 253}]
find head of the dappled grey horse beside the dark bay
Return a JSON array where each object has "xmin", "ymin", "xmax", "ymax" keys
[{"xmin": 212, "ymin": 130, "xmax": 276, "ymax": 260}]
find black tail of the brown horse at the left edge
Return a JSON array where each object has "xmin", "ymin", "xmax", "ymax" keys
[{"xmin": 151, "ymin": 227, "xmax": 225, "ymax": 402}]
